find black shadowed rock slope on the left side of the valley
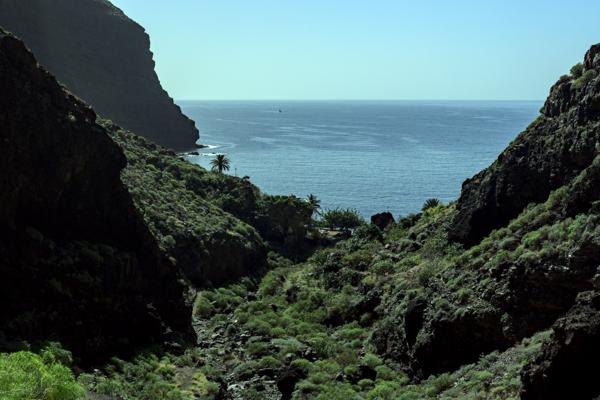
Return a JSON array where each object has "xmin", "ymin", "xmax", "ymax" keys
[{"xmin": 0, "ymin": 30, "xmax": 189, "ymax": 362}]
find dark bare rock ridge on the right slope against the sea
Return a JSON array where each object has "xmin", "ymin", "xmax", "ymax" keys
[{"xmin": 450, "ymin": 45, "xmax": 600, "ymax": 245}]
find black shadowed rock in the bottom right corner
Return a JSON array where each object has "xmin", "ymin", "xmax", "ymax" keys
[{"xmin": 521, "ymin": 291, "xmax": 600, "ymax": 400}]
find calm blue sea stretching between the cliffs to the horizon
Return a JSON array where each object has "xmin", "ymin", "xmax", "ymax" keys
[{"xmin": 180, "ymin": 101, "xmax": 542, "ymax": 218}]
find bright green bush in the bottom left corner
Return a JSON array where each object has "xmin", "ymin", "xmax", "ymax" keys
[{"xmin": 0, "ymin": 351, "xmax": 84, "ymax": 400}]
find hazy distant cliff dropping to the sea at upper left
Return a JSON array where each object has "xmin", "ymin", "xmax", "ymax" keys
[{"xmin": 0, "ymin": 0, "xmax": 198, "ymax": 150}]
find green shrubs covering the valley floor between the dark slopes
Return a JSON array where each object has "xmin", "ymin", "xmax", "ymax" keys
[{"xmin": 74, "ymin": 198, "xmax": 547, "ymax": 399}]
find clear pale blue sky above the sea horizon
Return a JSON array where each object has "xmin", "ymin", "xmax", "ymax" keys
[{"xmin": 113, "ymin": 0, "xmax": 600, "ymax": 100}]
